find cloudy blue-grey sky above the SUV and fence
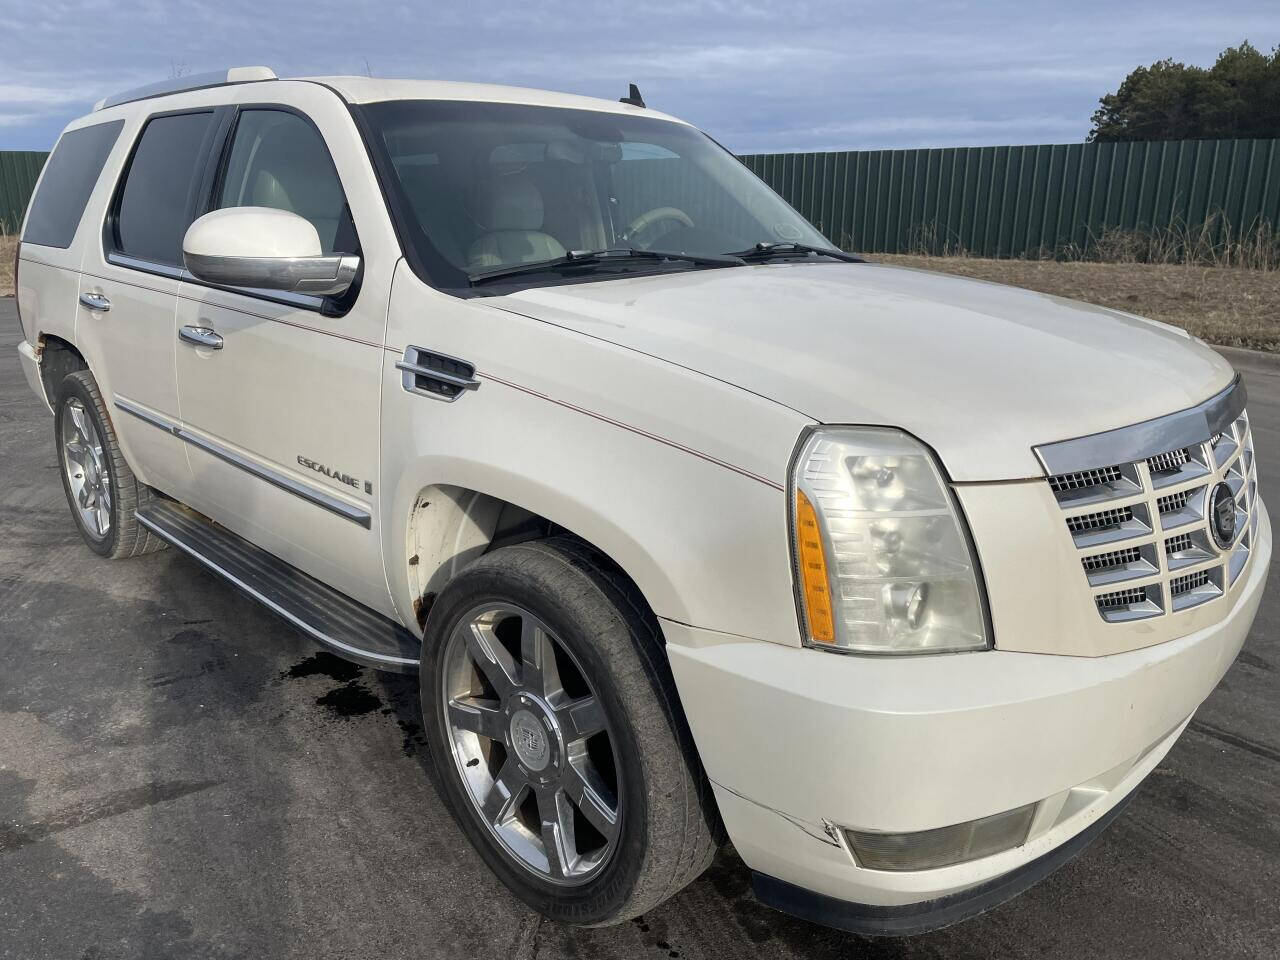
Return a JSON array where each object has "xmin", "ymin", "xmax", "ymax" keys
[{"xmin": 0, "ymin": 0, "xmax": 1280, "ymax": 152}]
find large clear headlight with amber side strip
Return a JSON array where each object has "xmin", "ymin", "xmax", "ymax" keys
[{"xmin": 791, "ymin": 426, "xmax": 991, "ymax": 654}]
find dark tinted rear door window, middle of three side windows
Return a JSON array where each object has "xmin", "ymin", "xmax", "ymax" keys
[{"xmin": 114, "ymin": 113, "xmax": 214, "ymax": 266}]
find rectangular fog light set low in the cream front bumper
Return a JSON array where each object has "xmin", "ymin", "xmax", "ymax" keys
[{"xmin": 845, "ymin": 804, "xmax": 1036, "ymax": 870}]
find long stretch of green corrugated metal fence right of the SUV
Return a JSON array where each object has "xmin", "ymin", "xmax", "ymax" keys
[{"xmin": 742, "ymin": 140, "xmax": 1280, "ymax": 257}]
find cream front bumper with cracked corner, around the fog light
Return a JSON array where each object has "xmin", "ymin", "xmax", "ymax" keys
[{"xmin": 663, "ymin": 504, "xmax": 1271, "ymax": 932}]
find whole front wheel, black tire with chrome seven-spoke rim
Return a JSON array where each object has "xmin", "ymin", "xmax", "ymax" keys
[{"xmin": 421, "ymin": 536, "xmax": 722, "ymax": 927}]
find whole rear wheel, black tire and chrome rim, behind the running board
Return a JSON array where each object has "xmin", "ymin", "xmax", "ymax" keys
[{"xmin": 54, "ymin": 370, "xmax": 168, "ymax": 559}]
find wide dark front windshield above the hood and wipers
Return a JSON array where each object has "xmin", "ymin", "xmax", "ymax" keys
[{"xmin": 364, "ymin": 100, "xmax": 832, "ymax": 293}]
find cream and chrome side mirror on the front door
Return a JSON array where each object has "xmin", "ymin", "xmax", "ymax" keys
[{"xmin": 182, "ymin": 206, "xmax": 360, "ymax": 297}]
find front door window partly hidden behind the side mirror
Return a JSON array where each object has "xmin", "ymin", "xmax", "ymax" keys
[{"xmin": 216, "ymin": 110, "xmax": 360, "ymax": 256}]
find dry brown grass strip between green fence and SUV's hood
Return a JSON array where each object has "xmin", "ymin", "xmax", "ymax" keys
[{"xmin": 868, "ymin": 253, "xmax": 1280, "ymax": 352}]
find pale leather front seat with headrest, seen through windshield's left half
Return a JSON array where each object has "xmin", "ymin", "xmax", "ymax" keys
[{"xmin": 467, "ymin": 173, "xmax": 564, "ymax": 270}]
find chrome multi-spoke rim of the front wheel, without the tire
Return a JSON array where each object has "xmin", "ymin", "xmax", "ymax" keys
[{"xmin": 440, "ymin": 604, "xmax": 622, "ymax": 886}]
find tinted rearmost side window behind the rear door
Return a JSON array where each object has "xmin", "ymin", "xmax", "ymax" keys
[{"xmin": 22, "ymin": 120, "xmax": 124, "ymax": 247}]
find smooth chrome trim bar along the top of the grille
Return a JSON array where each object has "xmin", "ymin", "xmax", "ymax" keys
[{"xmin": 1032, "ymin": 374, "xmax": 1247, "ymax": 476}]
